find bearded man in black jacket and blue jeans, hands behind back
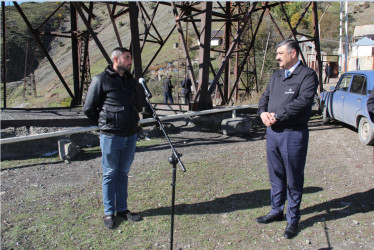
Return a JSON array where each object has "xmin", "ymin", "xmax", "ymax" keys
[{"xmin": 84, "ymin": 48, "xmax": 145, "ymax": 229}]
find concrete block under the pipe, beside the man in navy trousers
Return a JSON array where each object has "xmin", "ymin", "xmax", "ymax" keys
[{"xmin": 221, "ymin": 117, "xmax": 253, "ymax": 135}]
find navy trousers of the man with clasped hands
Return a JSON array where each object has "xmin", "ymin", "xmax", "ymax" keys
[{"xmin": 266, "ymin": 127, "xmax": 309, "ymax": 223}]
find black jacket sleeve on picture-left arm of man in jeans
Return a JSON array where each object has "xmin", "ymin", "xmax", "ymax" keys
[{"xmin": 83, "ymin": 75, "xmax": 103, "ymax": 125}]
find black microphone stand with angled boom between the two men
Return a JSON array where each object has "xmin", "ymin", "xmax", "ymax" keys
[{"xmin": 143, "ymin": 86, "xmax": 186, "ymax": 250}]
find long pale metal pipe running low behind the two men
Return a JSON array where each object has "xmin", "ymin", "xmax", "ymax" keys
[{"xmin": 0, "ymin": 104, "xmax": 258, "ymax": 145}]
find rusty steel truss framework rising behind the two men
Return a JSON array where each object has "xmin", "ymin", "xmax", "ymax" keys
[{"xmin": 1, "ymin": 1, "xmax": 322, "ymax": 110}]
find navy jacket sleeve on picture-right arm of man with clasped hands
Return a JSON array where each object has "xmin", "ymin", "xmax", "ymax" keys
[{"xmin": 277, "ymin": 70, "xmax": 318, "ymax": 121}]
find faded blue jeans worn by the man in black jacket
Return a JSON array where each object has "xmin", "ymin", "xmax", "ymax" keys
[{"xmin": 100, "ymin": 133, "xmax": 137, "ymax": 215}]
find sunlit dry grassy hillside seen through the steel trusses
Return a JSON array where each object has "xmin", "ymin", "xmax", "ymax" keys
[{"xmin": 7, "ymin": 2, "xmax": 374, "ymax": 108}]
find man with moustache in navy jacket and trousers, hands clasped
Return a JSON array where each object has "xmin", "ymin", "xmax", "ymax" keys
[{"xmin": 256, "ymin": 39, "xmax": 318, "ymax": 239}]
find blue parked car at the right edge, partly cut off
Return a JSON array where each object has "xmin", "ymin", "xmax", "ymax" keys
[{"xmin": 320, "ymin": 70, "xmax": 374, "ymax": 145}]
